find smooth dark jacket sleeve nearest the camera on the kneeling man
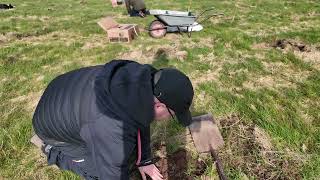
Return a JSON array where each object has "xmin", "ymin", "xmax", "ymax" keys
[{"xmin": 80, "ymin": 118, "xmax": 135, "ymax": 180}]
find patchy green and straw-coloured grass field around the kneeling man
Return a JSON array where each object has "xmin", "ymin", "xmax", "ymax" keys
[{"xmin": 0, "ymin": 0, "xmax": 320, "ymax": 180}]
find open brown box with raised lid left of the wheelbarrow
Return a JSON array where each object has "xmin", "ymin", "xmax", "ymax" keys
[{"xmin": 98, "ymin": 17, "xmax": 139, "ymax": 42}]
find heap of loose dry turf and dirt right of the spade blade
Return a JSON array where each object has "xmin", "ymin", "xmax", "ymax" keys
[{"xmin": 220, "ymin": 115, "xmax": 303, "ymax": 179}]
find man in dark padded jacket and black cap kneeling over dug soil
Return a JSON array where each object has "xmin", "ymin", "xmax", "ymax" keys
[{"xmin": 33, "ymin": 60, "xmax": 194, "ymax": 180}]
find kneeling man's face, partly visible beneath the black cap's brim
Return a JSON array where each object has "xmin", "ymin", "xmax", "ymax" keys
[{"xmin": 154, "ymin": 98, "xmax": 174, "ymax": 121}]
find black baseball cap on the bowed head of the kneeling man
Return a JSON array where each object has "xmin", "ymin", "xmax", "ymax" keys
[{"xmin": 153, "ymin": 68, "xmax": 194, "ymax": 126}]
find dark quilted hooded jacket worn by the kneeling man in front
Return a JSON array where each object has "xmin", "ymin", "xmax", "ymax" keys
[{"xmin": 33, "ymin": 60, "xmax": 156, "ymax": 180}]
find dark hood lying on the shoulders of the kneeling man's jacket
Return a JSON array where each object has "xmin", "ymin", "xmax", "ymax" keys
[{"xmin": 94, "ymin": 60, "xmax": 157, "ymax": 127}]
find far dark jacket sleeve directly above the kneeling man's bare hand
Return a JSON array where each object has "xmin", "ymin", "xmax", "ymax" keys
[{"xmin": 140, "ymin": 126, "xmax": 151, "ymax": 161}]
